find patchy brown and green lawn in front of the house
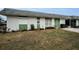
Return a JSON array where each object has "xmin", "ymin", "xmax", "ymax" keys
[{"xmin": 0, "ymin": 29, "xmax": 79, "ymax": 50}]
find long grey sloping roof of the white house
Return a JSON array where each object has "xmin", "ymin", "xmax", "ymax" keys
[{"xmin": 0, "ymin": 8, "xmax": 69, "ymax": 18}]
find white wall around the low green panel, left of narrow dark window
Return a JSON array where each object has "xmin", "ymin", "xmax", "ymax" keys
[{"xmin": 7, "ymin": 16, "xmax": 37, "ymax": 30}]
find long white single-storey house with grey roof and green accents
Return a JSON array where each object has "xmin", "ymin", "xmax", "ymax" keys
[{"xmin": 0, "ymin": 8, "xmax": 79, "ymax": 31}]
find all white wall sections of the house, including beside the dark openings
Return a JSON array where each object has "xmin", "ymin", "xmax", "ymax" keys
[{"xmin": 7, "ymin": 16, "xmax": 66, "ymax": 31}]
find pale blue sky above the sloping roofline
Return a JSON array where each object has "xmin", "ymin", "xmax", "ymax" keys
[{"xmin": 16, "ymin": 8, "xmax": 79, "ymax": 16}]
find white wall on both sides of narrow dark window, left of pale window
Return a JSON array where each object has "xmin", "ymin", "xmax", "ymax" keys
[{"xmin": 7, "ymin": 16, "xmax": 45, "ymax": 31}]
